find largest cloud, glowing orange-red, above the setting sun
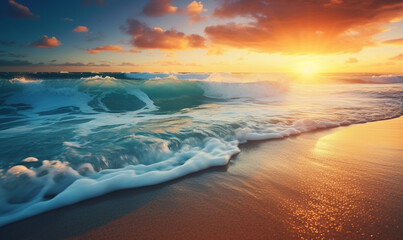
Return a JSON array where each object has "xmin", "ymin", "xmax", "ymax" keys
[{"xmin": 205, "ymin": 0, "xmax": 403, "ymax": 54}]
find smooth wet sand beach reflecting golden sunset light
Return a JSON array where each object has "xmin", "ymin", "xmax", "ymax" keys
[{"xmin": 0, "ymin": 117, "xmax": 403, "ymax": 239}]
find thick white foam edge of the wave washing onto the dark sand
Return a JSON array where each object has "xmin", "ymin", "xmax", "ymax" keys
[{"xmin": 0, "ymin": 139, "xmax": 239, "ymax": 226}]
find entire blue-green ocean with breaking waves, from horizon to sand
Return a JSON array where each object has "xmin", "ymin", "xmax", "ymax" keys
[{"xmin": 0, "ymin": 73, "xmax": 403, "ymax": 226}]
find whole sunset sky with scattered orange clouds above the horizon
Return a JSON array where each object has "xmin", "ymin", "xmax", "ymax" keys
[{"xmin": 0, "ymin": 0, "xmax": 403, "ymax": 74}]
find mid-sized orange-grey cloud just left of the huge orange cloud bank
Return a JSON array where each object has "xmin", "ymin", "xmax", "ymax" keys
[{"xmin": 121, "ymin": 19, "xmax": 205, "ymax": 50}]
